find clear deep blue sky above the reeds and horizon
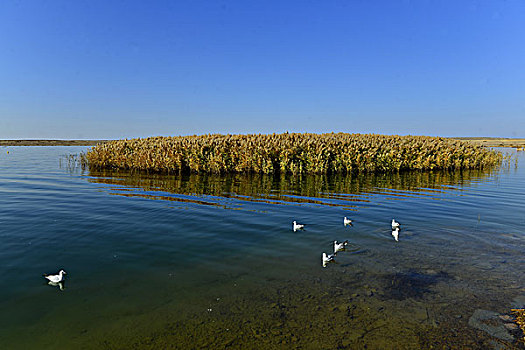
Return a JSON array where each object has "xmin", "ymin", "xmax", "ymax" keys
[{"xmin": 0, "ymin": 0, "xmax": 525, "ymax": 139}]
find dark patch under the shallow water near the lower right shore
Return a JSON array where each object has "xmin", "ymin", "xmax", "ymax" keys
[{"xmin": 383, "ymin": 270, "xmax": 450, "ymax": 300}]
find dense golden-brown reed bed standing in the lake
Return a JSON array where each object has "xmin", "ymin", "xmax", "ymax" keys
[{"xmin": 85, "ymin": 133, "xmax": 503, "ymax": 174}]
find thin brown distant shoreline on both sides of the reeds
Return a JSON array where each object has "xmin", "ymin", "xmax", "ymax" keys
[{"xmin": 0, "ymin": 137, "xmax": 525, "ymax": 148}]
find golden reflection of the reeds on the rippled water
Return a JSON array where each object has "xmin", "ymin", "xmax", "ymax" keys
[{"xmin": 84, "ymin": 170, "xmax": 494, "ymax": 209}]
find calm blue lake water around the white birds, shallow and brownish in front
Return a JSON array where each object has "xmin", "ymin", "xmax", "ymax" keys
[{"xmin": 0, "ymin": 147, "xmax": 525, "ymax": 349}]
